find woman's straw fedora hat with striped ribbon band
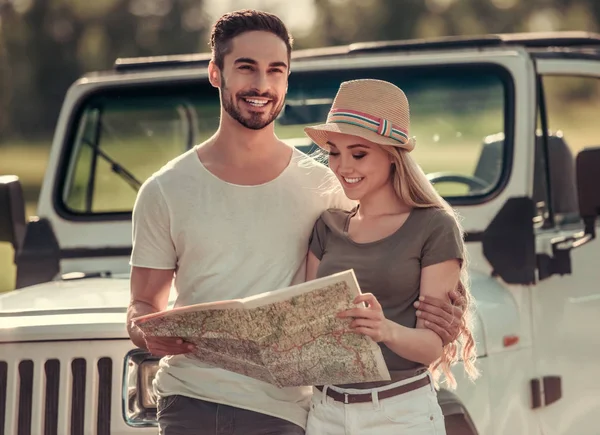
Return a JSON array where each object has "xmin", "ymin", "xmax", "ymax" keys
[{"xmin": 304, "ymin": 79, "xmax": 415, "ymax": 151}]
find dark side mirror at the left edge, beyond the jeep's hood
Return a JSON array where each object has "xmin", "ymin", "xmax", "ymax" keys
[{"xmin": 0, "ymin": 175, "xmax": 27, "ymax": 255}]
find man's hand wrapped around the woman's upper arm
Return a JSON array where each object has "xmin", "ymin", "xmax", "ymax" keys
[{"xmin": 414, "ymin": 290, "xmax": 465, "ymax": 346}]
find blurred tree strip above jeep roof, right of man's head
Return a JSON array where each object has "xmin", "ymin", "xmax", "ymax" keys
[{"xmin": 313, "ymin": 0, "xmax": 600, "ymax": 45}]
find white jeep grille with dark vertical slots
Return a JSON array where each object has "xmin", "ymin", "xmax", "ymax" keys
[{"xmin": 0, "ymin": 340, "xmax": 139, "ymax": 435}]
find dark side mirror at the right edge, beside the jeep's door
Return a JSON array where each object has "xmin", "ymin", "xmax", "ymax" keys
[{"xmin": 575, "ymin": 147, "xmax": 600, "ymax": 239}]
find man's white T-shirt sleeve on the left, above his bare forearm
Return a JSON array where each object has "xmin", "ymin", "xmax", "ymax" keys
[{"xmin": 129, "ymin": 178, "xmax": 177, "ymax": 269}]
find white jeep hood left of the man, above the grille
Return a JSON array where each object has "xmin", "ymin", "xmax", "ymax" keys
[{"xmin": 0, "ymin": 278, "xmax": 174, "ymax": 342}]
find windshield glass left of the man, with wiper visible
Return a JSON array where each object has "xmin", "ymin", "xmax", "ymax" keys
[{"xmin": 63, "ymin": 96, "xmax": 194, "ymax": 213}]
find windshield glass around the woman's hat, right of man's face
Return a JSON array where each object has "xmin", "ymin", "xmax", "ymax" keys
[{"xmin": 276, "ymin": 67, "xmax": 509, "ymax": 198}]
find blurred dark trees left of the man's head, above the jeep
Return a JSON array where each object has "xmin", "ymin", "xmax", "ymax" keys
[{"xmin": 0, "ymin": 0, "xmax": 210, "ymax": 140}]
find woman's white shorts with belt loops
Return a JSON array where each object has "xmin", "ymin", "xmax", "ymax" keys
[{"xmin": 306, "ymin": 372, "xmax": 446, "ymax": 435}]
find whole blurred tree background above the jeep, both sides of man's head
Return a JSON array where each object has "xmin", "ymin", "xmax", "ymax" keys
[{"xmin": 0, "ymin": 0, "xmax": 600, "ymax": 143}]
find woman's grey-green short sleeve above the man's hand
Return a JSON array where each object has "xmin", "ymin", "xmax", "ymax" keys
[{"xmin": 421, "ymin": 210, "xmax": 464, "ymax": 267}]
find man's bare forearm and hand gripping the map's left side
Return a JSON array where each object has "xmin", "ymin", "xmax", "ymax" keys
[{"xmin": 127, "ymin": 266, "xmax": 193, "ymax": 356}]
